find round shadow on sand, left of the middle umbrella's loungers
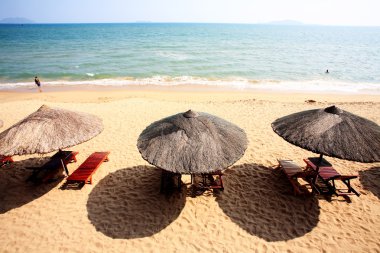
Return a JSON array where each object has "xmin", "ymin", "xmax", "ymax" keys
[{"xmin": 87, "ymin": 166, "xmax": 186, "ymax": 239}]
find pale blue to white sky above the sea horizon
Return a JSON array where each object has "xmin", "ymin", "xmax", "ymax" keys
[{"xmin": 0, "ymin": 0, "xmax": 380, "ymax": 26}]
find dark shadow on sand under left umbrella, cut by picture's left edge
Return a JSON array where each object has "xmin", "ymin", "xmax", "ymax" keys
[{"xmin": 0, "ymin": 158, "xmax": 63, "ymax": 214}]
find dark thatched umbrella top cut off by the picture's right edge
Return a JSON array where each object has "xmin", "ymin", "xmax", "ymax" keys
[{"xmin": 272, "ymin": 106, "xmax": 380, "ymax": 163}]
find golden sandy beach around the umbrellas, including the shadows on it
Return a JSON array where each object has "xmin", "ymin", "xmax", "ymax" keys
[{"xmin": 0, "ymin": 87, "xmax": 380, "ymax": 253}]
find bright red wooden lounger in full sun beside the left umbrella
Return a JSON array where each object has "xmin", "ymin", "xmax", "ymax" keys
[{"xmin": 66, "ymin": 152, "xmax": 110, "ymax": 184}]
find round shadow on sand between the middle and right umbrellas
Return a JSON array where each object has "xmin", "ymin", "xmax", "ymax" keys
[{"xmin": 216, "ymin": 164, "xmax": 320, "ymax": 242}]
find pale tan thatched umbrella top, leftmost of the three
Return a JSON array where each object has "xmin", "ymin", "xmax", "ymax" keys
[{"xmin": 0, "ymin": 105, "xmax": 103, "ymax": 156}]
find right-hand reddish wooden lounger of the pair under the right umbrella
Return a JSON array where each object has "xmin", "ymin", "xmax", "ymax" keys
[{"xmin": 304, "ymin": 157, "xmax": 360, "ymax": 197}]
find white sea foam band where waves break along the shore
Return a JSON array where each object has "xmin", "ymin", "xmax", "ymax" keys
[{"xmin": 0, "ymin": 75, "xmax": 380, "ymax": 94}]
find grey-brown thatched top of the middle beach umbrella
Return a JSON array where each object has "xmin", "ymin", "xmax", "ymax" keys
[{"xmin": 137, "ymin": 110, "xmax": 248, "ymax": 174}]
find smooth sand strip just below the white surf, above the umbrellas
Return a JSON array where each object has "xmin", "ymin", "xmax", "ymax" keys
[{"xmin": 0, "ymin": 85, "xmax": 380, "ymax": 104}]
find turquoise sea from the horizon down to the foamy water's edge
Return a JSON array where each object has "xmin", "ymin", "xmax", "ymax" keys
[{"xmin": 0, "ymin": 23, "xmax": 380, "ymax": 93}]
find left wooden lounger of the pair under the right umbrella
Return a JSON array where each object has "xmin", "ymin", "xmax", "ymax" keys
[{"xmin": 278, "ymin": 160, "xmax": 315, "ymax": 195}]
